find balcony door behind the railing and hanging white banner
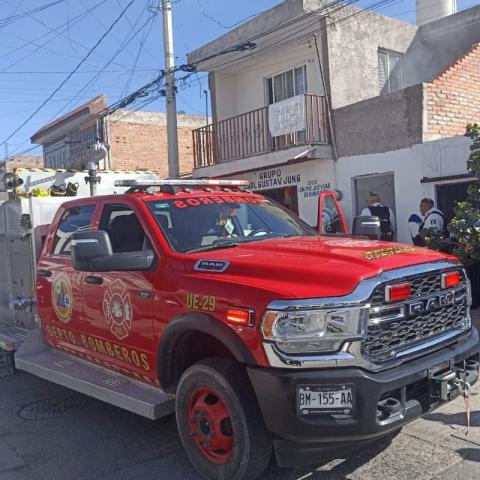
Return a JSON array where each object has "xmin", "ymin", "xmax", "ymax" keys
[{"xmin": 266, "ymin": 65, "xmax": 307, "ymax": 150}]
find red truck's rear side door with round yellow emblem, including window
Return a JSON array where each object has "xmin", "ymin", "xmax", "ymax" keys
[{"xmin": 36, "ymin": 204, "xmax": 96, "ymax": 349}]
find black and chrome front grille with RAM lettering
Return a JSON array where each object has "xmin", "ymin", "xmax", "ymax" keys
[{"xmin": 363, "ymin": 271, "xmax": 469, "ymax": 362}]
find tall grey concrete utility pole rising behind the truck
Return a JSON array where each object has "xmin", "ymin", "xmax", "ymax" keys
[{"xmin": 162, "ymin": 0, "xmax": 179, "ymax": 178}]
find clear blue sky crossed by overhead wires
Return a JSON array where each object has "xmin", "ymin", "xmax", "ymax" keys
[{"xmin": 0, "ymin": 0, "xmax": 480, "ymax": 159}]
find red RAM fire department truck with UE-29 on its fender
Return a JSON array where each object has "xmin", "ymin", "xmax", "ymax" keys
[{"xmin": 16, "ymin": 180, "xmax": 479, "ymax": 480}]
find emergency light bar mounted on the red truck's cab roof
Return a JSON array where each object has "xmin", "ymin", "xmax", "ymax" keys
[{"xmin": 115, "ymin": 179, "xmax": 250, "ymax": 194}]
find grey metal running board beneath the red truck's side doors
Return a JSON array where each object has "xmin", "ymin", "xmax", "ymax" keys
[{"xmin": 15, "ymin": 329, "xmax": 175, "ymax": 420}]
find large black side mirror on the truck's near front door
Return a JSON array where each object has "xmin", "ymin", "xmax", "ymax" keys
[{"xmin": 70, "ymin": 230, "xmax": 113, "ymax": 272}]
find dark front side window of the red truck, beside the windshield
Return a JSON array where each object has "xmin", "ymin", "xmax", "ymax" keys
[{"xmin": 100, "ymin": 205, "xmax": 146, "ymax": 253}]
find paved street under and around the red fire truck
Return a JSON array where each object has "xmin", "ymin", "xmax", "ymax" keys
[{"xmin": 0, "ymin": 364, "xmax": 480, "ymax": 480}]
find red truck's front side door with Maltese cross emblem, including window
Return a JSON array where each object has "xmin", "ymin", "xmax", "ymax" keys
[{"xmin": 81, "ymin": 202, "xmax": 156, "ymax": 380}]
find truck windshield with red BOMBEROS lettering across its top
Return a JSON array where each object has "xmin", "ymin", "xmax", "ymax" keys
[{"xmin": 146, "ymin": 195, "xmax": 317, "ymax": 253}]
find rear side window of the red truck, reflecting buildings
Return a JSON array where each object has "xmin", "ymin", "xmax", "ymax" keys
[{"xmin": 52, "ymin": 205, "xmax": 95, "ymax": 255}]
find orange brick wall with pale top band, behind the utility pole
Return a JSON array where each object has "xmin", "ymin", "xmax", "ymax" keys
[{"xmin": 108, "ymin": 111, "xmax": 205, "ymax": 177}]
